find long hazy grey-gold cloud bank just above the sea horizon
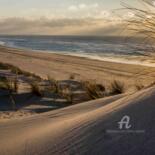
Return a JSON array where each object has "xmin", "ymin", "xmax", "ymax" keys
[{"xmin": 0, "ymin": 18, "xmax": 127, "ymax": 35}]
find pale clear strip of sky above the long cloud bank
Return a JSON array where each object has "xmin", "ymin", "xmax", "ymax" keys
[{"xmin": 0, "ymin": 0, "xmax": 121, "ymax": 17}]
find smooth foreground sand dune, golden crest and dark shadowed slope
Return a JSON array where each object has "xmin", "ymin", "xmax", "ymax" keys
[{"xmin": 0, "ymin": 88, "xmax": 155, "ymax": 155}]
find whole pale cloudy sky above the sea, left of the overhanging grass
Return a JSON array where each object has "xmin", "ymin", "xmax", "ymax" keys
[{"xmin": 0, "ymin": 0, "xmax": 140, "ymax": 35}]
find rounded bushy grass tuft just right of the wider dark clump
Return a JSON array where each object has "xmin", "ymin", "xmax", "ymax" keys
[{"xmin": 110, "ymin": 80, "xmax": 125, "ymax": 95}]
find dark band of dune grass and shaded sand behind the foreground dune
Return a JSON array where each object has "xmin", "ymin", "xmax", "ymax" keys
[{"xmin": 0, "ymin": 63, "xmax": 152, "ymax": 112}]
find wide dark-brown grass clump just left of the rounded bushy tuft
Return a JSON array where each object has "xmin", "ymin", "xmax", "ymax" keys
[{"xmin": 82, "ymin": 81, "xmax": 106, "ymax": 99}]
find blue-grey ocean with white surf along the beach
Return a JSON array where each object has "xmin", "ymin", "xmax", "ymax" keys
[{"xmin": 0, "ymin": 36, "xmax": 153, "ymax": 63}]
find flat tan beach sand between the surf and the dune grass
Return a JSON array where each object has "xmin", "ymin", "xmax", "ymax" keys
[{"xmin": 0, "ymin": 46, "xmax": 155, "ymax": 87}]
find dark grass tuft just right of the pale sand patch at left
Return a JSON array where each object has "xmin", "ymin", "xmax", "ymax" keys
[{"xmin": 30, "ymin": 82, "xmax": 43, "ymax": 97}]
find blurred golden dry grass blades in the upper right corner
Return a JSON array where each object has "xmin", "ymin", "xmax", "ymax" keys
[{"xmin": 121, "ymin": 0, "xmax": 155, "ymax": 55}]
